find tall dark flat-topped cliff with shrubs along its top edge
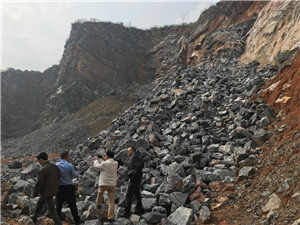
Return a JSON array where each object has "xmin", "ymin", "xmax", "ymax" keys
[{"xmin": 44, "ymin": 22, "xmax": 189, "ymax": 123}]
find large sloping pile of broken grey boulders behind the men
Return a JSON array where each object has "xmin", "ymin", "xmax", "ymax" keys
[{"xmin": 1, "ymin": 59, "xmax": 276, "ymax": 225}]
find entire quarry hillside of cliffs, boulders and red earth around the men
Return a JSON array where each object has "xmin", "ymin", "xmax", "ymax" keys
[{"xmin": 1, "ymin": 1, "xmax": 300, "ymax": 225}]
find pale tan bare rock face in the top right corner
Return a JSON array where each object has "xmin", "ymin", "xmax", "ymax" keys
[{"xmin": 241, "ymin": 1, "xmax": 300, "ymax": 66}]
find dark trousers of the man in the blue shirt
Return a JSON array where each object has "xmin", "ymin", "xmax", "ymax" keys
[{"xmin": 56, "ymin": 184, "xmax": 80, "ymax": 223}]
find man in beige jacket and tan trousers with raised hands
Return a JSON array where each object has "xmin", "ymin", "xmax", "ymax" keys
[{"xmin": 94, "ymin": 150, "xmax": 118, "ymax": 222}]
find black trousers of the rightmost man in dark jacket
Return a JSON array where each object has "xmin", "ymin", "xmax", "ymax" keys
[{"xmin": 125, "ymin": 178, "xmax": 144, "ymax": 215}]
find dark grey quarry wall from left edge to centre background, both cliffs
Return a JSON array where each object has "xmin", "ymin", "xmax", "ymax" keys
[{"xmin": 2, "ymin": 22, "xmax": 190, "ymax": 139}]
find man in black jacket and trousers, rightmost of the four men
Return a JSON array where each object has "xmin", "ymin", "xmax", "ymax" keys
[{"xmin": 124, "ymin": 147, "xmax": 144, "ymax": 218}]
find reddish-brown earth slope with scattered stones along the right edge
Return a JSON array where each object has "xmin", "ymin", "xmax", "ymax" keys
[{"xmin": 213, "ymin": 48, "xmax": 300, "ymax": 225}]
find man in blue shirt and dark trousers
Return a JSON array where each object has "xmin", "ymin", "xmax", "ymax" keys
[{"xmin": 56, "ymin": 151, "xmax": 82, "ymax": 224}]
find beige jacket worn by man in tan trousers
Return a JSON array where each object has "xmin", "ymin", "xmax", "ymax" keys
[{"xmin": 94, "ymin": 159, "xmax": 118, "ymax": 186}]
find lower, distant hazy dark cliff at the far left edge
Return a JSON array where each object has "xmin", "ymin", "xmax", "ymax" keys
[{"xmin": 1, "ymin": 66, "xmax": 58, "ymax": 140}]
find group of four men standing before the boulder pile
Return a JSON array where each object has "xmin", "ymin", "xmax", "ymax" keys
[{"xmin": 32, "ymin": 147, "xmax": 144, "ymax": 225}]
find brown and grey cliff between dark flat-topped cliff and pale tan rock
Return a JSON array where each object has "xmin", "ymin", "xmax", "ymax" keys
[{"xmin": 186, "ymin": 1, "xmax": 268, "ymax": 65}]
